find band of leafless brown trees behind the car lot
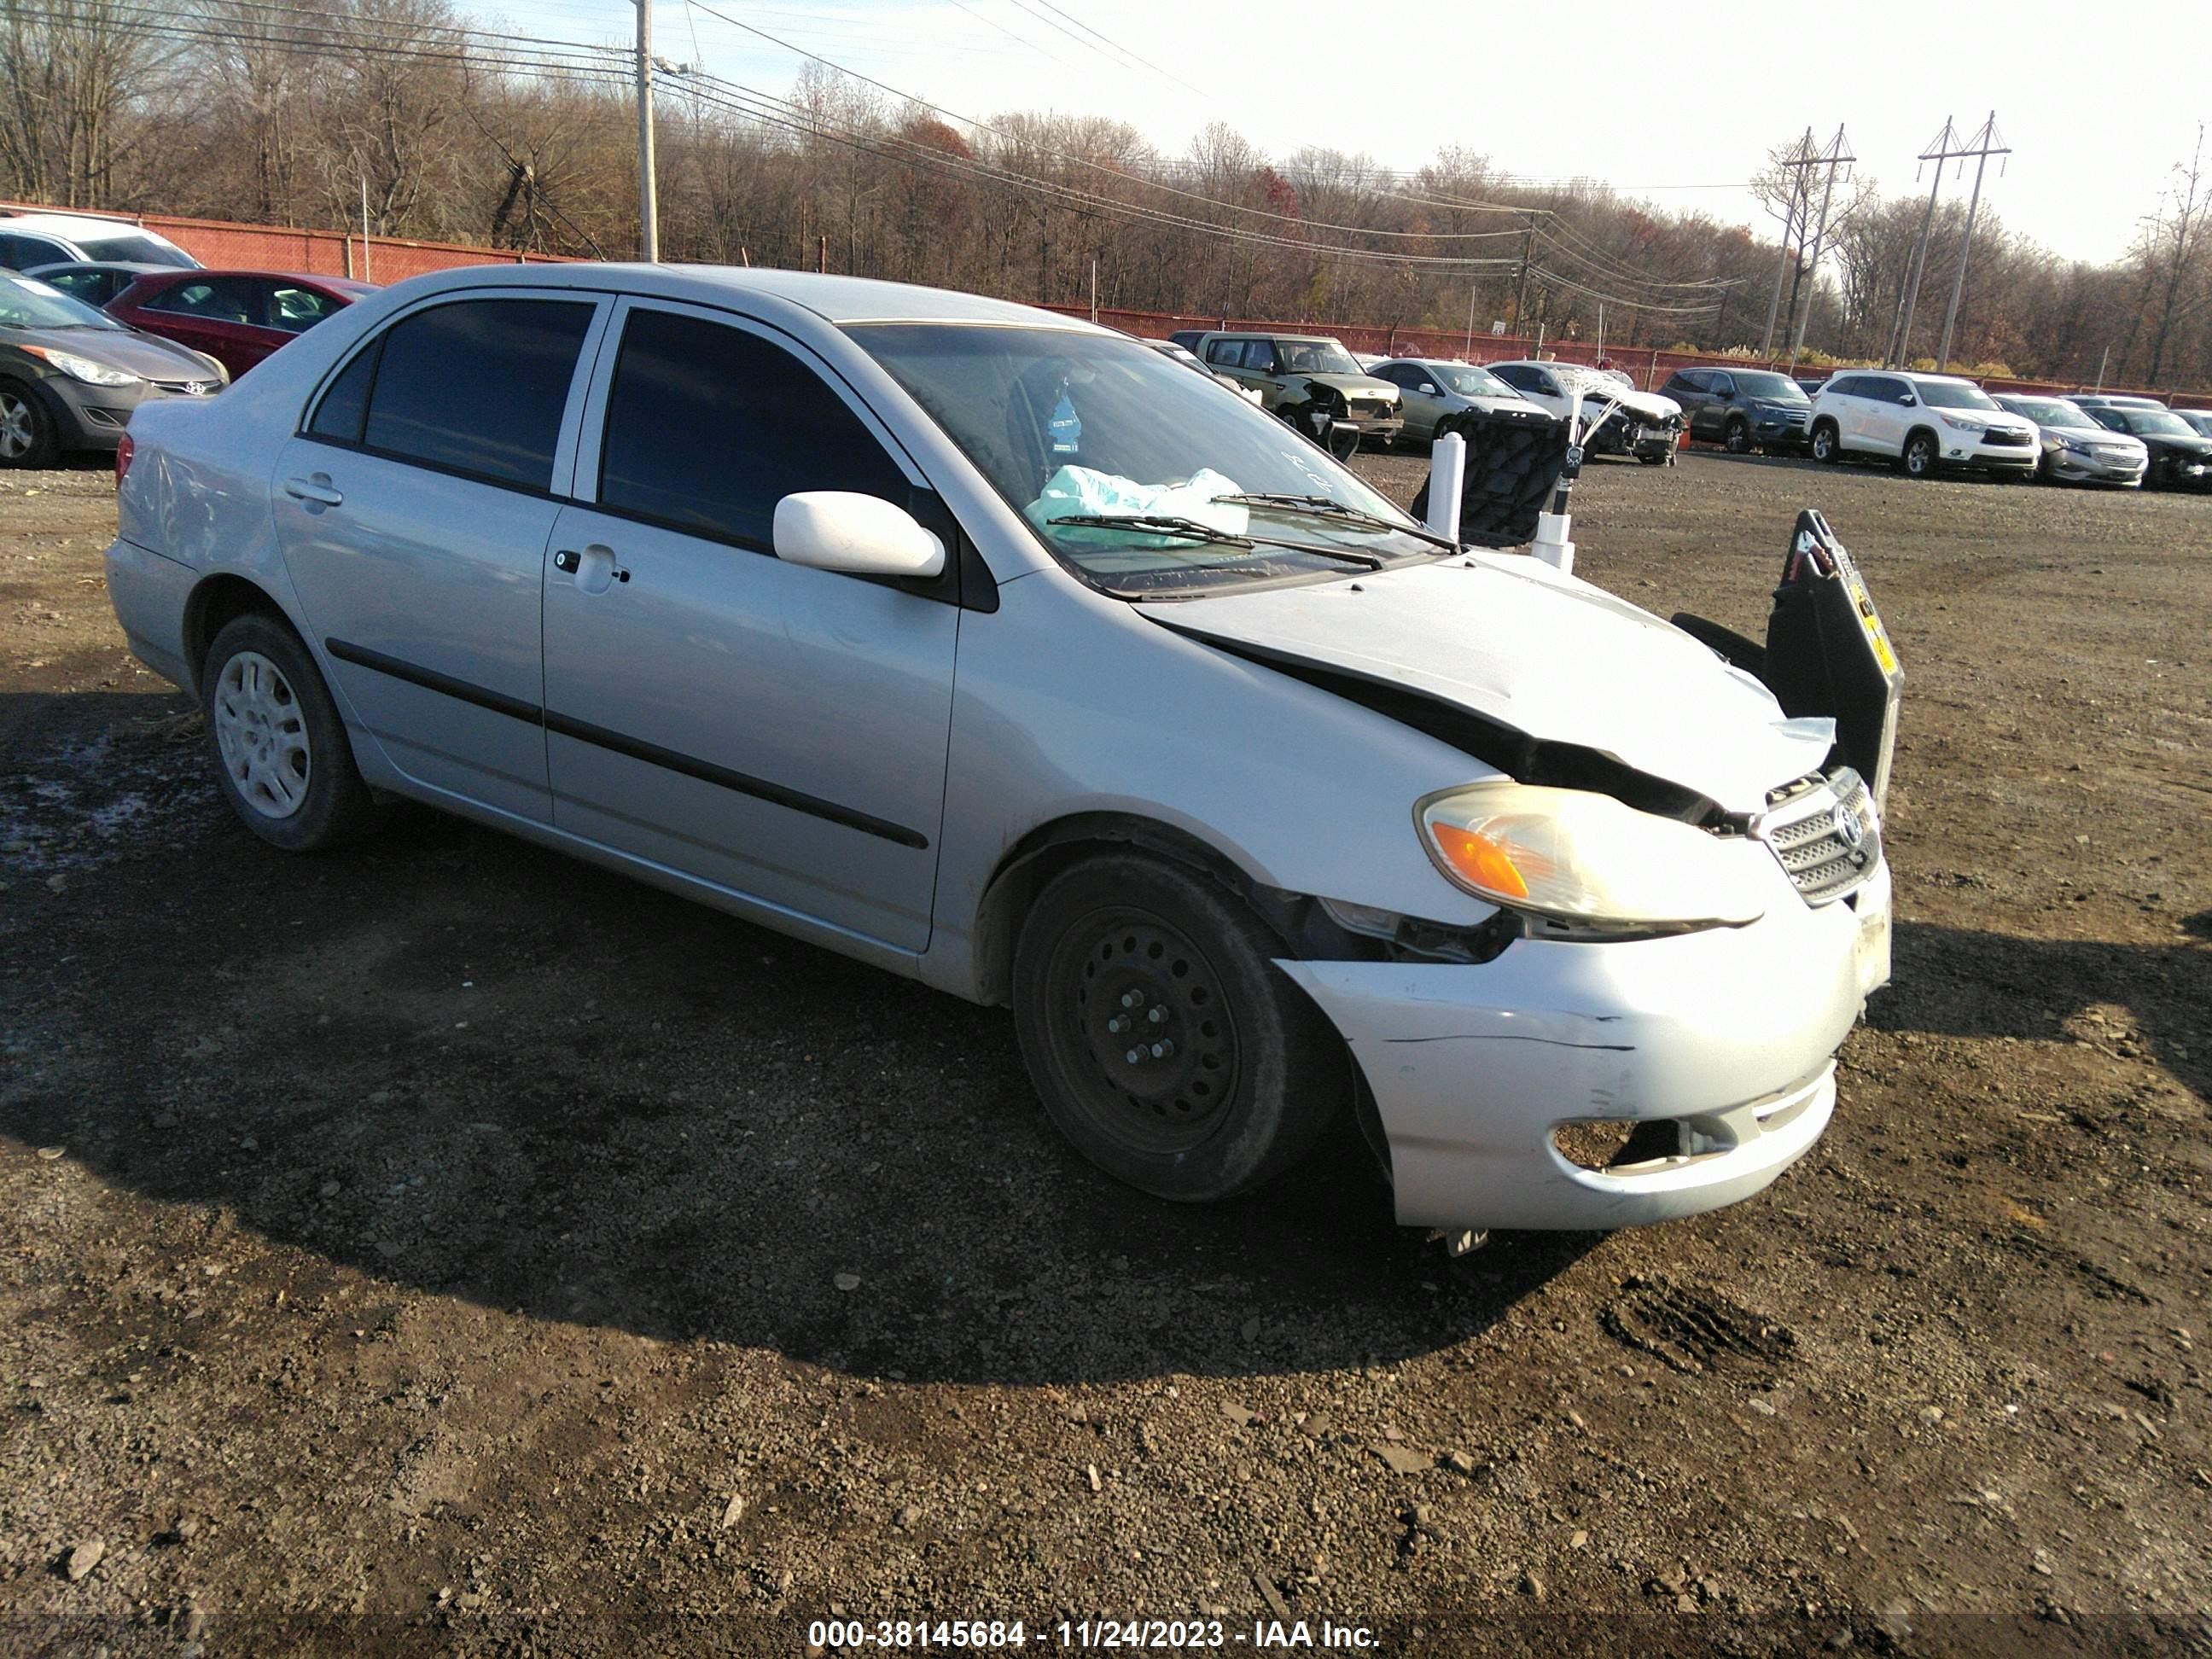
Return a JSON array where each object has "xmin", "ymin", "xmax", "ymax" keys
[{"xmin": 0, "ymin": 0, "xmax": 2212, "ymax": 387}]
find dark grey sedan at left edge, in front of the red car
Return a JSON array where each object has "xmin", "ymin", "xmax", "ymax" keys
[{"xmin": 0, "ymin": 274, "xmax": 224, "ymax": 467}]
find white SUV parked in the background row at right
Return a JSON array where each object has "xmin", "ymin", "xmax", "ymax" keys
[{"xmin": 1812, "ymin": 371, "xmax": 2041, "ymax": 478}]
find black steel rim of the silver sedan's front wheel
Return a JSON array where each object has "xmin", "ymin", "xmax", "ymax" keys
[{"xmin": 1046, "ymin": 907, "xmax": 1243, "ymax": 1155}]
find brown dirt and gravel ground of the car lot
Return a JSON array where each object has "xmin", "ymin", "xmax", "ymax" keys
[{"xmin": 0, "ymin": 456, "xmax": 2212, "ymax": 1655}]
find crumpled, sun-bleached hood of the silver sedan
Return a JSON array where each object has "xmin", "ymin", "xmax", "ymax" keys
[{"xmin": 1139, "ymin": 553, "xmax": 1836, "ymax": 812}]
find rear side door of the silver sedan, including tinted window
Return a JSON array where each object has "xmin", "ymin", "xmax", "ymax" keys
[{"xmin": 270, "ymin": 290, "xmax": 606, "ymax": 823}]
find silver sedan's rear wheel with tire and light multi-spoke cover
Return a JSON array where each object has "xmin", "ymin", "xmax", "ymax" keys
[{"xmin": 199, "ymin": 610, "xmax": 382, "ymax": 852}]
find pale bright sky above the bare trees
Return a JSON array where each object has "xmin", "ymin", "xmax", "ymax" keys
[{"xmin": 488, "ymin": 0, "xmax": 2212, "ymax": 261}]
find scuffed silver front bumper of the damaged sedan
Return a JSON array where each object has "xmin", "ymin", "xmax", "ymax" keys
[{"xmin": 1281, "ymin": 864, "xmax": 1891, "ymax": 1230}]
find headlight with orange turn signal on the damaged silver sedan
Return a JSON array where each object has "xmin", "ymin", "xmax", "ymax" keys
[{"xmin": 1413, "ymin": 783, "xmax": 1772, "ymax": 931}]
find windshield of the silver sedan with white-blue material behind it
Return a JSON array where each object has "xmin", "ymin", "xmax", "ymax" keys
[{"xmin": 847, "ymin": 323, "xmax": 1438, "ymax": 593}]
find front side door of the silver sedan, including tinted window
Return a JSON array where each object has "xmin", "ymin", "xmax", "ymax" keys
[{"xmin": 544, "ymin": 301, "xmax": 960, "ymax": 952}]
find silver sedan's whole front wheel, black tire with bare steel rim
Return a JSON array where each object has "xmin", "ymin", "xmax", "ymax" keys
[{"xmin": 1013, "ymin": 854, "xmax": 1352, "ymax": 1203}]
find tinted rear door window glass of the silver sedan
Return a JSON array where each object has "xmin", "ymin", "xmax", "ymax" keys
[{"xmin": 363, "ymin": 299, "xmax": 593, "ymax": 489}]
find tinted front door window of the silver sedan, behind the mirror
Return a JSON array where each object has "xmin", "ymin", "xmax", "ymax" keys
[{"xmin": 599, "ymin": 310, "xmax": 906, "ymax": 553}]
